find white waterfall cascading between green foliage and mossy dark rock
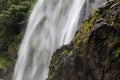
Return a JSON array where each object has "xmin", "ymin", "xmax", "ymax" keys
[{"xmin": 13, "ymin": 0, "xmax": 103, "ymax": 80}]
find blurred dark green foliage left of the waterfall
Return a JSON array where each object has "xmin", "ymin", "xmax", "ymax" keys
[{"xmin": 0, "ymin": 0, "xmax": 35, "ymax": 80}]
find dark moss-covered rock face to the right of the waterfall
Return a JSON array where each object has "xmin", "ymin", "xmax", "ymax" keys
[{"xmin": 47, "ymin": 0, "xmax": 120, "ymax": 80}]
